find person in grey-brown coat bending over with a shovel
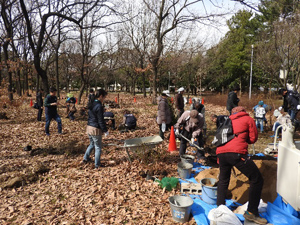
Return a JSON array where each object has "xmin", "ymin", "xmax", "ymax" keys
[{"xmin": 174, "ymin": 110, "xmax": 205, "ymax": 160}]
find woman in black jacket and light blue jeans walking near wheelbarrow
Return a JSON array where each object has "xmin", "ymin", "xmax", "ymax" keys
[{"xmin": 83, "ymin": 89, "xmax": 108, "ymax": 169}]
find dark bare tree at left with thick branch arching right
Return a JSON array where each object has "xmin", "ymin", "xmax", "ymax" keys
[{"xmin": 20, "ymin": 0, "xmax": 105, "ymax": 92}]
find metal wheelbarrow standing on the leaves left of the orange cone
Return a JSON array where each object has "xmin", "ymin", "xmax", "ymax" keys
[{"xmin": 123, "ymin": 135, "xmax": 163, "ymax": 163}]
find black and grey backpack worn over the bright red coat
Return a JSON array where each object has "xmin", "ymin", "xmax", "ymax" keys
[{"xmin": 212, "ymin": 118, "xmax": 236, "ymax": 147}]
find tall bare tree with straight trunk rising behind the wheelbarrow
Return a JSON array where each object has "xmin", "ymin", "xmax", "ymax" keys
[{"xmin": 143, "ymin": 0, "xmax": 227, "ymax": 104}]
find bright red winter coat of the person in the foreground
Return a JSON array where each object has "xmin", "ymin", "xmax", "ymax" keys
[{"xmin": 216, "ymin": 112, "xmax": 258, "ymax": 155}]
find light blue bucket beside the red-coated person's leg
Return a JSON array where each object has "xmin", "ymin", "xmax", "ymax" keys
[{"xmin": 200, "ymin": 178, "xmax": 217, "ymax": 205}]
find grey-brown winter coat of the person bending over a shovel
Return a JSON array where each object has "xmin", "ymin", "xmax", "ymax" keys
[{"xmin": 174, "ymin": 111, "xmax": 204, "ymax": 138}]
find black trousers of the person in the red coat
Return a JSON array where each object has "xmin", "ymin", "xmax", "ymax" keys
[{"xmin": 217, "ymin": 153, "xmax": 264, "ymax": 216}]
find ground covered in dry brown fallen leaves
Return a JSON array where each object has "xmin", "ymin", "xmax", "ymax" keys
[{"xmin": 0, "ymin": 94, "xmax": 282, "ymax": 224}]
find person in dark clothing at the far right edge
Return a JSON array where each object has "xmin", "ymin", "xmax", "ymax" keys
[{"xmin": 278, "ymin": 89, "xmax": 300, "ymax": 121}]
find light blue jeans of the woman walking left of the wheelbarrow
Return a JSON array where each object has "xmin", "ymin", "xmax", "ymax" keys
[{"xmin": 83, "ymin": 135, "xmax": 102, "ymax": 168}]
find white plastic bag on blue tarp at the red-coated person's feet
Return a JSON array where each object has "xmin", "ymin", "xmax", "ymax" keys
[{"xmin": 208, "ymin": 205, "xmax": 242, "ymax": 225}]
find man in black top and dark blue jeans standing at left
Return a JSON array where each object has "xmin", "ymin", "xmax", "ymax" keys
[{"xmin": 44, "ymin": 87, "xmax": 62, "ymax": 136}]
